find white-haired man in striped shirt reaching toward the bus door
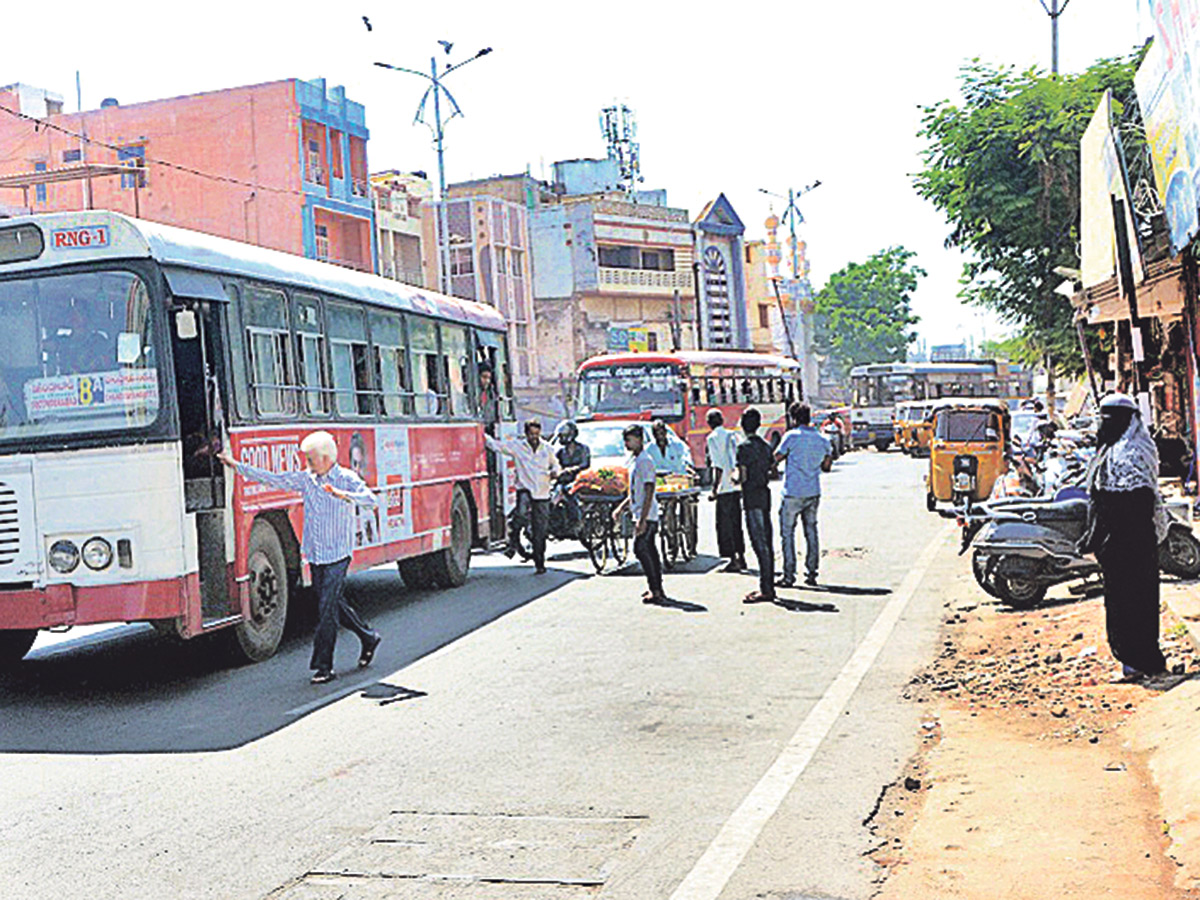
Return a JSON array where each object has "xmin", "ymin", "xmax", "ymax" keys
[{"xmin": 217, "ymin": 431, "xmax": 383, "ymax": 684}]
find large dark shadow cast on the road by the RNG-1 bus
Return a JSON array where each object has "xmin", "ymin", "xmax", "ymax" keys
[{"xmin": 0, "ymin": 563, "xmax": 581, "ymax": 755}]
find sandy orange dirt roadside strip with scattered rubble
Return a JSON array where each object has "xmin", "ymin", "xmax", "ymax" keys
[{"xmin": 865, "ymin": 575, "xmax": 1200, "ymax": 900}]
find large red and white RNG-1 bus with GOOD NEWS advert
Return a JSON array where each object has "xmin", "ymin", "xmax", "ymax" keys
[{"xmin": 0, "ymin": 212, "xmax": 514, "ymax": 661}]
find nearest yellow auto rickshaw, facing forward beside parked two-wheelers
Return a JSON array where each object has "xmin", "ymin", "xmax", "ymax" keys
[{"xmin": 925, "ymin": 397, "xmax": 1010, "ymax": 511}]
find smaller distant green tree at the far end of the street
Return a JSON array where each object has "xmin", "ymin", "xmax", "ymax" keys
[{"xmin": 814, "ymin": 247, "xmax": 925, "ymax": 376}]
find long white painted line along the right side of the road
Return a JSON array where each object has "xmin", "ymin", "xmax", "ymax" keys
[{"xmin": 671, "ymin": 524, "xmax": 952, "ymax": 900}]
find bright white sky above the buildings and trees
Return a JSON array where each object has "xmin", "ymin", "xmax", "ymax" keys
[{"xmin": 7, "ymin": 0, "xmax": 1144, "ymax": 343}]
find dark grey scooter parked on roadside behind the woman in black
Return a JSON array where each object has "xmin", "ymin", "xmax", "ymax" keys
[{"xmin": 958, "ymin": 487, "xmax": 1200, "ymax": 608}]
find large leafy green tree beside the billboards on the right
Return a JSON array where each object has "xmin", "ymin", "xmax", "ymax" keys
[{"xmin": 914, "ymin": 50, "xmax": 1142, "ymax": 400}]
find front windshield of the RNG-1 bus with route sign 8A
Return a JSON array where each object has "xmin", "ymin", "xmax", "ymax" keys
[{"xmin": 0, "ymin": 271, "xmax": 160, "ymax": 440}]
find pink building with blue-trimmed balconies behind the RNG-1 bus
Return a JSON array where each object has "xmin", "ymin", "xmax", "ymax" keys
[{"xmin": 0, "ymin": 79, "xmax": 376, "ymax": 271}]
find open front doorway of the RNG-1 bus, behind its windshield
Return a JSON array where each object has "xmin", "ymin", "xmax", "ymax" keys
[{"xmin": 170, "ymin": 298, "xmax": 238, "ymax": 623}]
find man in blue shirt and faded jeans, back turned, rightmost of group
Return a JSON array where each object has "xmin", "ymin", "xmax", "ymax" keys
[{"xmin": 775, "ymin": 403, "xmax": 833, "ymax": 588}]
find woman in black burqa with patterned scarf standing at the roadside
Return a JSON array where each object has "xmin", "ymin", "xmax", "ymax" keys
[{"xmin": 1084, "ymin": 394, "xmax": 1166, "ymax": 682}]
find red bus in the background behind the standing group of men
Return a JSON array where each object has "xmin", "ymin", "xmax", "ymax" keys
[{"xmin": 576, "ymin": 350, "xmax": 804, "ymax": 469}]
